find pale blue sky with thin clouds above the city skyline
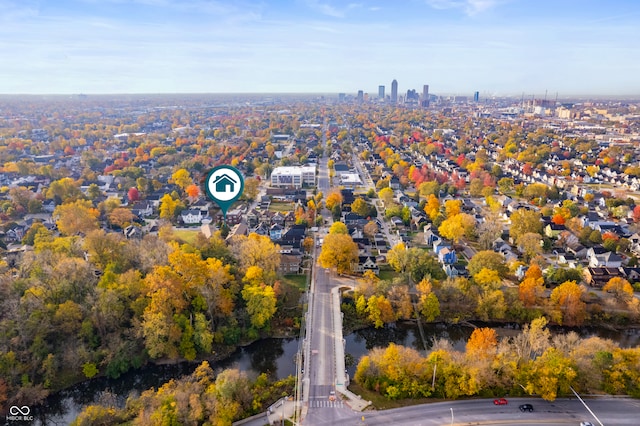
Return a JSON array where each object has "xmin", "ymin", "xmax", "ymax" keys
[{"xmin": 0, "ymin": 0, "xmax": 640, "ymax": 97}]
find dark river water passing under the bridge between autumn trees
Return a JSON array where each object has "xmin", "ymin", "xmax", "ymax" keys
[{"xmin": 33, "ymin": 323, "xmax": 640, "ymax": 425}]
